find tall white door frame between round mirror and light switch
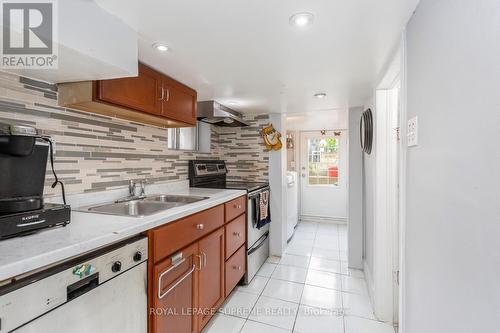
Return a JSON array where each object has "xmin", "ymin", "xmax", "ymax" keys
[{"xmin": 367, "ymin": 32, "xmax": 407, "ymax": 326}]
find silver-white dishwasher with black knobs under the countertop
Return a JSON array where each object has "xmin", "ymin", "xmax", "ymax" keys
[{"xmin": 0, "ymin": 236, "xmax": 148, "ymax": 333}]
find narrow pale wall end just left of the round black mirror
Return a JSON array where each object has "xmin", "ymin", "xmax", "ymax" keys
[{"xmin": 347, "ymin": 107, "xmax": 363, "ymax": 269}]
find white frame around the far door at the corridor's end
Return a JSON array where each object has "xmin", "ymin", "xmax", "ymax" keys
[{"xmin": 295, "ymin": 129, "xmax": 349, "ymax": 223}]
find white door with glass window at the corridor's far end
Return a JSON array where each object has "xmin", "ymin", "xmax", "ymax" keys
[{"xmin": 300, "ymin": 131, "xmax": 347, "ymax": 219}]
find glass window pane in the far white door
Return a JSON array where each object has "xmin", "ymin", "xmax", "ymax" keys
[{"xmin": 307, "ymin": 136, "xmax": 339, "ymax": 186}]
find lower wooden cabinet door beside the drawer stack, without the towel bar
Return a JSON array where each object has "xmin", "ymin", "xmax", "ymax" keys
[{"xmin": 198, "ymin": 228, "xmax": 224, "ymax": 331}]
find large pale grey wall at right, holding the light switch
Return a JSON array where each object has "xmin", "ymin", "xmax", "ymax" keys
[{"xmin": 403, "ymin": 0, "xmax": 500, "ymax": 333}]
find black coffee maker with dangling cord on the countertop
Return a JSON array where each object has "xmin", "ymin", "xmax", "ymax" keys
[{"xmin": 0, "ymin": 123, "xmax": 70, "ymax": 238}]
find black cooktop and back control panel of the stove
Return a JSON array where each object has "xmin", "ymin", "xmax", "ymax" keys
[{"xmin": 189, "ymin": 160, "xmax": 269, "ymax": 193}]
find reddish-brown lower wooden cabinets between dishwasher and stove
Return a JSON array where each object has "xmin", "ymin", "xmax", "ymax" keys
[{"xmin": 148, "ymin": 201, "xmax": 246, "ymax": 333}]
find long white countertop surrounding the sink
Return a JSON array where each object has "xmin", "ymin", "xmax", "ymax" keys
[{"xmin": 0, "ymin": 188, "xmax": 246, "ymax": 281}]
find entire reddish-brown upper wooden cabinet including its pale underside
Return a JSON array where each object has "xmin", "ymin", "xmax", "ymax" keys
[{"xmin": 58, "ymin": 64, "xmax": 197, "ymax": 127}]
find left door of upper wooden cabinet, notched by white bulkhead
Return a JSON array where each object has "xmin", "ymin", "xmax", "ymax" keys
[{"xmin": 95, "ymin": 64, "xmax": 162, "ymax": 115}]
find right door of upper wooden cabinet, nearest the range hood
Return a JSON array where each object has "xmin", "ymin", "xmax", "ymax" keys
[{"xmin": 162, "ymin": 77, "xmax": 197, "ymax": 125}]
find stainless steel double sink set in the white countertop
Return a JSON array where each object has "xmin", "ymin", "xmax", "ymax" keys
[{"xmin": 76, "ymin": 194, "xmax": 209, "ymax": 217}]
